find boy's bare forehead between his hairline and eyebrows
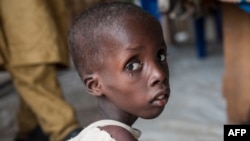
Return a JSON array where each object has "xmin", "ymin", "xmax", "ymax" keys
[{"xmin": 102, "ymin": 17, "xmax": 163, "ymax": 52}]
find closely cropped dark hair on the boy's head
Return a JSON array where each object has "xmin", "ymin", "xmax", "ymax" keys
[{"xmin": 68, "ymin": 2, "xmax": 160, "ymax": 76}]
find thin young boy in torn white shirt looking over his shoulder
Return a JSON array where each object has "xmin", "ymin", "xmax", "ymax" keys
[{"xmin": 68, "ymin": 2, "xmax": 170, "ymax": 141}]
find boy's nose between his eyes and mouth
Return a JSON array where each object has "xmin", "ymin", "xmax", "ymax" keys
[{"xmin": 149, "ymin": 64, "xmax": 167, "ymax": 87}]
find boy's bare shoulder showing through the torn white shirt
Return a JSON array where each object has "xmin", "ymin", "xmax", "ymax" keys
[{"xmin": 98, "ymin": 125, "xmax": 138, "ymax": 141}]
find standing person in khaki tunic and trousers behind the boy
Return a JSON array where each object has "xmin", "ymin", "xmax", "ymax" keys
[{"xmin": 0, "ymin": 0, "xmax": 80, "ymax": 141}]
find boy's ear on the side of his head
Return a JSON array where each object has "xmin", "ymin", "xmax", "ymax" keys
[{"xmin": 83, "ymin": 74, "xmax": 102, "ymax": 96}]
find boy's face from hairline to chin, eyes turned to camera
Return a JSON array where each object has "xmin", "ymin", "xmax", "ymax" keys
[{"xmin": 97, "ymin": 15, "xmax": 170, "ymax": 119}]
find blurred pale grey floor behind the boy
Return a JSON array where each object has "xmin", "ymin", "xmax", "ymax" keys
[{"xmin": 0, "ymin": 44, "xmax": 226, "ymax": 141}]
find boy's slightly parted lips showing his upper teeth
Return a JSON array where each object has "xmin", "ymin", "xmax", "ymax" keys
[{"xmin": 150, "ymin": 90, "xmax": 169, "ymax": 107}]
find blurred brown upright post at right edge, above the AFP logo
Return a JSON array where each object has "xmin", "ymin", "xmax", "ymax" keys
[{"xmin": 221, "ymin": 0, "xmax": 250, "ymax": 124}]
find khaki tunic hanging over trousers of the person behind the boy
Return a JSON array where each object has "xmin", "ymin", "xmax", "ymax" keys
[{"xmin": 0, "ymin": 0, "xmax": 69, "ymax": 67}]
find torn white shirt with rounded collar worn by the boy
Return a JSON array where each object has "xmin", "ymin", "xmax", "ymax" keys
[{"xmin": 69, "ymin": 120, "xmax": 141, "ymax": 141}]
